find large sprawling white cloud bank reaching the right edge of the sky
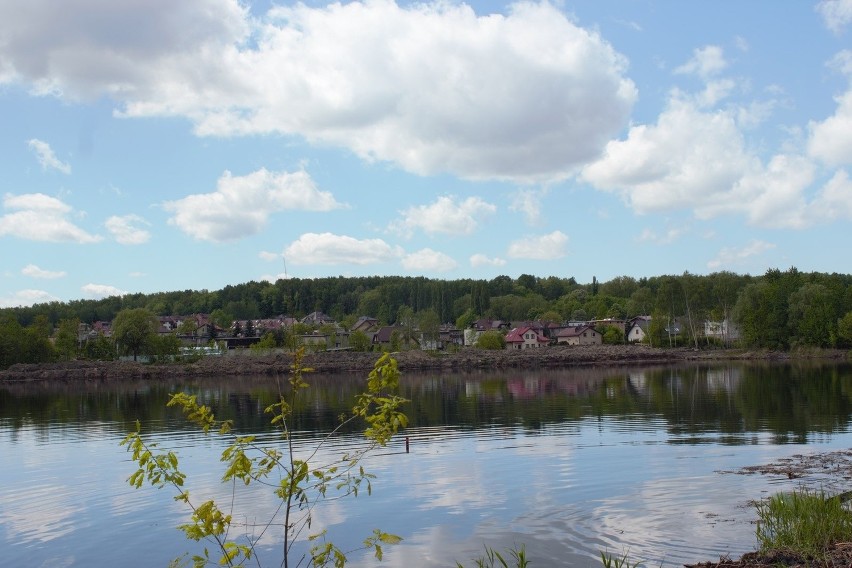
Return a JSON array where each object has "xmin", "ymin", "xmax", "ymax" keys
[{"xmin": 581, "ymin": 70, "xmax": 852, "ymax": 230}]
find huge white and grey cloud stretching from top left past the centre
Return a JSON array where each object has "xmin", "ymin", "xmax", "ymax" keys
[{"xmin": 0, "ymin": 0, "xmax": 637, "ymax": 182}]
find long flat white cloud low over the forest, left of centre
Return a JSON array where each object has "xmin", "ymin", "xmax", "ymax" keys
[{"xmin": 284, "ymin": 233, "xmax": 403, "ymax": 266}]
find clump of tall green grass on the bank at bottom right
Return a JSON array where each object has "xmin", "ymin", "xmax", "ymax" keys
[{"xmin": 756, "ymin": 490, "xmax": 852, "ymax": 560}]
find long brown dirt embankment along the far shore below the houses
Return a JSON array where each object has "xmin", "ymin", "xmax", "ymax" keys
[{"xmin": 0, "ymin": 345, "xmax": 846, "ymax": 381}]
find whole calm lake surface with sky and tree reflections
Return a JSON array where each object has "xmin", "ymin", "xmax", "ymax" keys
[{"xmin": 0, "ymin": 364, "xmax": 852, "ymax": 568}]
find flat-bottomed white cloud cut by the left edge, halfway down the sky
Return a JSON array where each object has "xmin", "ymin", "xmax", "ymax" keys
[{"xmin": 0, "ymin": 193, "xmax": 102, "ymax": 244}]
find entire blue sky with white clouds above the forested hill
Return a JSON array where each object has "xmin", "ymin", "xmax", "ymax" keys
[{"xmin": 0, "ymin": 0, "xmax": 852, "ymax": 307}]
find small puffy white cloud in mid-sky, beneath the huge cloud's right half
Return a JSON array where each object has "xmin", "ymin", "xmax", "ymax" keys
[{"xmin": 391, "ymin": 195, "xmax": 497, "ymax": 235}]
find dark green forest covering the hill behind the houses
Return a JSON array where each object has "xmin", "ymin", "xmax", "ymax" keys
[{"xmin": 5, "ymin": 267, "xmax": 852, "ymax": 370}]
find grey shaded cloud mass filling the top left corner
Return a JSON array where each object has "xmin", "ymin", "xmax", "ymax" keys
[{"xmin": 0, "ymin": 0, "xmax": 249, "ymax": 96}]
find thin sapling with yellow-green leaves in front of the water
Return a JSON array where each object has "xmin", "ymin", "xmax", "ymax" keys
[{"xmin": 121, "ymin": 350, "xmax": 408, "ymax": 567}]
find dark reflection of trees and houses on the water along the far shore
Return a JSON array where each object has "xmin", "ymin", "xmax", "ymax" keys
[{"xmin": 0, "ymin": 364, "xmax": 852, "ymax": 444}]
